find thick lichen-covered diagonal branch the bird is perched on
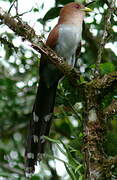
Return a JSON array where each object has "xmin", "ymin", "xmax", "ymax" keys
[{"xmin": 0, "ymin": 8, "xmax": 80, "ymax": 85}]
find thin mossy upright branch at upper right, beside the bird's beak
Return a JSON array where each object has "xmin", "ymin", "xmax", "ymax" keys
[{"xmin": 95, "ymin": 0, "xmax": 115, "ymax": 77}]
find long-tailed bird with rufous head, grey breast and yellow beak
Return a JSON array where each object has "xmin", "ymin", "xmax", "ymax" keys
[{"xmin": 25, "ymin": 2, "xmax": 92, "ymax": 173}]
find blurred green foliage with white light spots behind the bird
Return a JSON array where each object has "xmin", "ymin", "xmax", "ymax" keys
[{"xmin": 0, "ymin": 0, "xmax": 117, "ymax": 180}]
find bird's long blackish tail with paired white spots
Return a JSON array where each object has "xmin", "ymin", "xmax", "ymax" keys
[{"xmin": 25, "ymin": 80, "xmax": 58, "ymax": 173}]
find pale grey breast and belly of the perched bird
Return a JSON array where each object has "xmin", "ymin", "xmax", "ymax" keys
[{"xmin": 55, "ymin": 24, "xmax": 82, "ymax": 66}]
